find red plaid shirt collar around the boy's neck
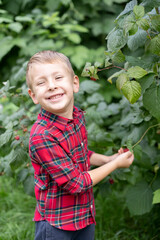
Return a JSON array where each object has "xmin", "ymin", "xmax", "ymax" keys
[{"xmin": 40, "ymin": 106, "xmax": 82, "ymax": 131}]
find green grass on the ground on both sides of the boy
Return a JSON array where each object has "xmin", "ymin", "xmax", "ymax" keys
[{"xmin": 0, "ymin": 176, "xmax": 160, "ymax": 240}]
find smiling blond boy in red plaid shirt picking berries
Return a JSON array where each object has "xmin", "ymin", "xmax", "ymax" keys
[{"xmin": 26, "ymin": 51, "xmax": 134, "ymax": 240}]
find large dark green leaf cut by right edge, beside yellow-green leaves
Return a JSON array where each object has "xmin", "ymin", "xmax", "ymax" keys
[{"xmin": 143, "ymin": 83, "xmax": 160, "ymax": 120}]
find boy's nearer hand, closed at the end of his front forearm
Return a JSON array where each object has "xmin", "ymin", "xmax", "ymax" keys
[{"xmin": 115, "ymin": 151, "xmax": 134, "ymax": 168}]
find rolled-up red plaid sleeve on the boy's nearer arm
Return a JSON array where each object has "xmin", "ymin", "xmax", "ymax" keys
[{"xmin": 30, "ymin": 134, "xmax": 92, "ymax": 194}]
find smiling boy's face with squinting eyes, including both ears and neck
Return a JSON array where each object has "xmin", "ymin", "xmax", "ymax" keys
[{"xmin": 28, "ymin": 62, "xmax": 79, "ymax": 118}]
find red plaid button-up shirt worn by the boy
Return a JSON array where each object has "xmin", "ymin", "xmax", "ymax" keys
[{"xmin": 29, "ymin": 107, "xmax": 95, "ymax": 231}]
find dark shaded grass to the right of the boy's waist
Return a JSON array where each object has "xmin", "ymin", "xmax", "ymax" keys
[{"xmin": 95, "ymin": 191, "xmax": 160, "ymax": 240}]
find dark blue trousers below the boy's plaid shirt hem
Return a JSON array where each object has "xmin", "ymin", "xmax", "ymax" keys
[{"xmin": 35, "ymin": 221, "xmax": 95, "ymax": 240}]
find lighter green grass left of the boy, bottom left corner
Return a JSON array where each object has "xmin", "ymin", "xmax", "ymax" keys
[{"xmin": 0, "ymin": 176, "xmax": 35, "ymax": 240}]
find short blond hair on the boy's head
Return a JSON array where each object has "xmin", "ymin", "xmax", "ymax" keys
[{"xmin": 26, "ymin": 50, "xmax": 75, "ymax": 88}]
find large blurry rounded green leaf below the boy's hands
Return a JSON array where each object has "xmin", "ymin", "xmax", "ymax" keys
[{"xmin": 126, "ymin": 182, "xmax": 153, "ymax": 215}]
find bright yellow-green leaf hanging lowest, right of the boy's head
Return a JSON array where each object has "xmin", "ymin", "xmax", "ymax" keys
[{"xmin": 122, "ymin": 81, "xmax": 141, "ymax": 104}]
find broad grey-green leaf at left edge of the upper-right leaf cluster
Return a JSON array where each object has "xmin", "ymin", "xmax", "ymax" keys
[{"xmin": 107, "ymin": 29, "xmax": 127, "ymax": 52}]
